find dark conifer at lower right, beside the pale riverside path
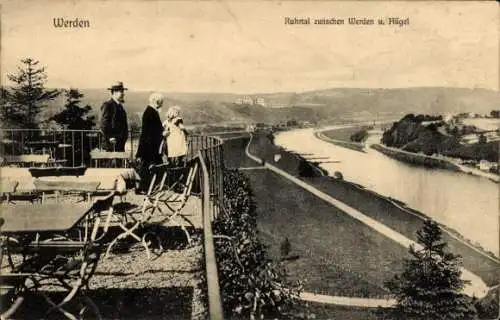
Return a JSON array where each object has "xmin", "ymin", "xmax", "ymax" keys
[{"xmin": 386, "ymin": 220, "xmax": 476, "ymax": 320}]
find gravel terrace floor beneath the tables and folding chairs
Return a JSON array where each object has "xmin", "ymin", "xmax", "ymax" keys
[{"xmin": 2, "ymin": 191, "xmax": 207, "ymax": 319}]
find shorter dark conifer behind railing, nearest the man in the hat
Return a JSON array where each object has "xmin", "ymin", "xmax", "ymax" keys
[{"xmin": 51, "ymin": 88, "xmax": 95, "ymax": 130}]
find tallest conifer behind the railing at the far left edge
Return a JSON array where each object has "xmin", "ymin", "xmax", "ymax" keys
[{"xmin": 4, "ymin": 58, "xmax": 60, "ymax": 128}]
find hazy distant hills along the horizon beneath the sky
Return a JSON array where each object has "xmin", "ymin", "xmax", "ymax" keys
[{"xmin": 44, "ymin": 87, "xmax": 500, "ymax": 124}]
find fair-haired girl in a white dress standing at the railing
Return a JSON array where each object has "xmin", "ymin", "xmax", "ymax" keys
[{"xmin": 161, "ymin": 105, "xmax": 187, "ymax": 167}]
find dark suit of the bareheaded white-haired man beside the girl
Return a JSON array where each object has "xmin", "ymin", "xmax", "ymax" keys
[{"xmin": 135, "ymin": 106, "xmax": 163, "ymax": 164}]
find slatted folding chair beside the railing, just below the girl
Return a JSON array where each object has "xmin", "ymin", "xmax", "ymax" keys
[{"xmin": 156, "ymin": 159, "xmax": 198, "ymax": 244}]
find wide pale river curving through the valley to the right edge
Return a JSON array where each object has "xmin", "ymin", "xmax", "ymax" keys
[{"xmin": 275, "ymin": 127, "xmax": 499, "ymax": 256}]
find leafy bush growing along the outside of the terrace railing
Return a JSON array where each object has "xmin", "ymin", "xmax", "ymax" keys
[{"xmin": 214, "ymin": 170, "xmax": 301, "ymax": 319}]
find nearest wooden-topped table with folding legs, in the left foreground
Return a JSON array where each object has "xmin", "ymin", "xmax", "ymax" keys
[{"xmin": 0, "ymin": 193, "xmax": 114, "ymax": 319}]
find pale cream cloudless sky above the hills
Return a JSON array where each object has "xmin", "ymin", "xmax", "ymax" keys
[{"xmin": 0, "ymin": 0, "xmax": 499, "ymax": 93}]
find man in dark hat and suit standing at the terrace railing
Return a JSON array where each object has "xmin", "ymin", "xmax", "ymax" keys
[{"xmin": 101, "ymin": 82, "xmax": 128, "ymax": 152}]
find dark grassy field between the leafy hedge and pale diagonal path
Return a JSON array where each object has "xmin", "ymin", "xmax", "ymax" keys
[{"xmin": 245, "ymin": 170, "xmax": 407, "ymax": 297}]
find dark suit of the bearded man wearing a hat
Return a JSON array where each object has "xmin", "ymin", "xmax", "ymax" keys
[{"xmin": 101, "ymin": 99, "xmax": 128, "ymax": 151}]
